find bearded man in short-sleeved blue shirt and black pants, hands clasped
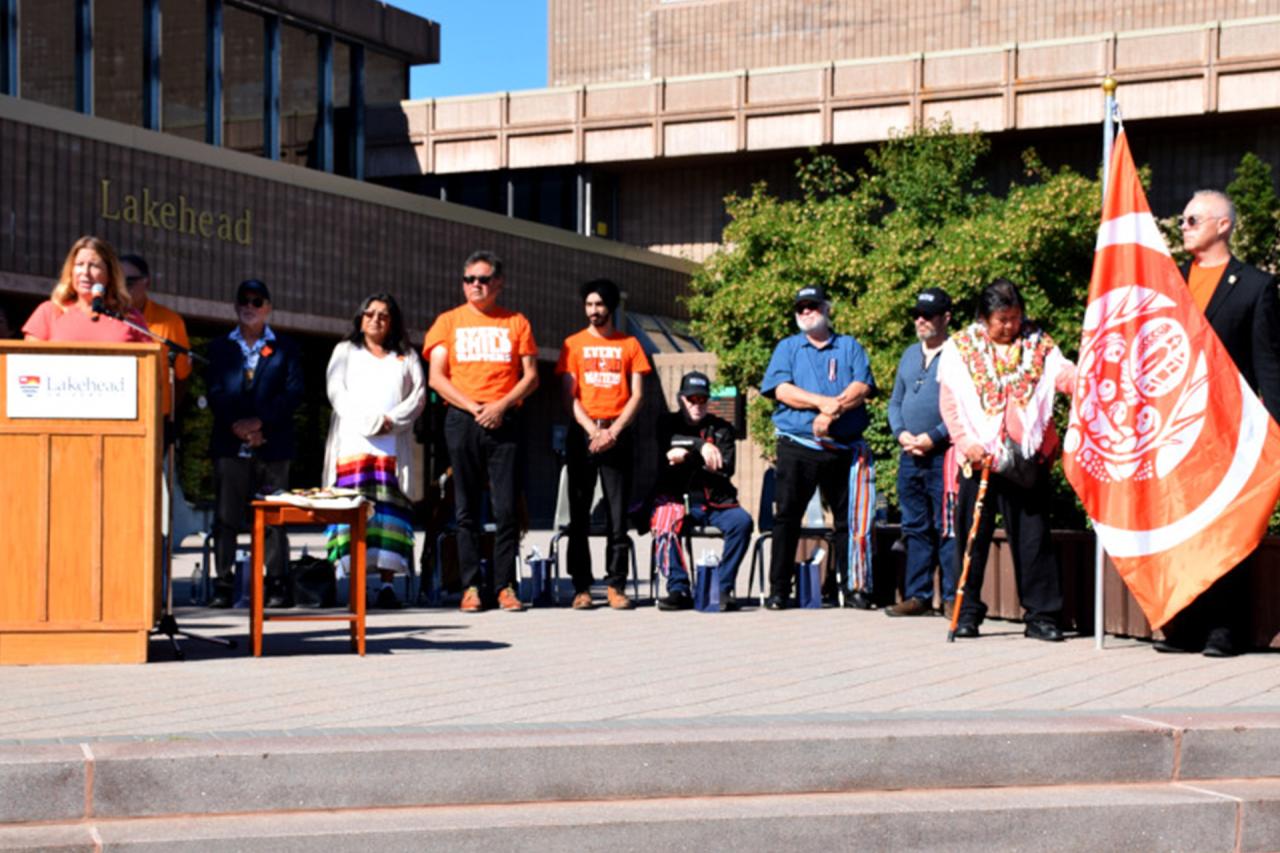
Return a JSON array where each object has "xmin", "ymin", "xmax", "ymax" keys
[{"xmin": 760, "ymin": 284, "xmax": 876, "ymax": 610}]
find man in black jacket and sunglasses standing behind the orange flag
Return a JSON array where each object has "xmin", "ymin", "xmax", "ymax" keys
[{"xmin": 1156, "ymin": 190, "xmax": 1280, "ymax": 657}]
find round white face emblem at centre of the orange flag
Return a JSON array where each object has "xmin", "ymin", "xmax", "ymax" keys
[{"xmin": 1064, "ymin": 284, "xmax": 1208, "ymax": 483}]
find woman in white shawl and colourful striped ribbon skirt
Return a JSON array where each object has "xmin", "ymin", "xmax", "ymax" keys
[{"xmin": 324, "ymin": 293, "xmax": 426, "ymax": 608}]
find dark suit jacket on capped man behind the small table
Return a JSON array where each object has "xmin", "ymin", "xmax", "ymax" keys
[{"xmin": 206, "ymin": 329, "xmax": 303, "ymax": 461}]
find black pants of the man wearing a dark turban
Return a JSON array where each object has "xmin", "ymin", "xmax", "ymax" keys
[{"xmin": 564, "ymin": 424, "xmax": 631, "ymax": 593}]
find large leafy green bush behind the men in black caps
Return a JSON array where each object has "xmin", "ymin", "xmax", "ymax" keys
[{"xmin": 689, "ymin": 124, "xmax": 1101, "ymax": 523}]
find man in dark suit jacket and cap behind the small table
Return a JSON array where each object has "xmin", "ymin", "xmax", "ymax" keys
[{"xmin": 207, "ymin": 278, "xmax": 303, "ymax": 607}]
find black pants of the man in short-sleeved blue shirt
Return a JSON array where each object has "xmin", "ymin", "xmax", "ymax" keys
[{"xmin": 769, "ymin": 437, "xmax": 854, "ymax": 598}]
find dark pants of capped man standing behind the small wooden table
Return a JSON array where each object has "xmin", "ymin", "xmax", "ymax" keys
[{"xmin": 214, "ymin": 456, "xmax": 289, "ymax": 588}]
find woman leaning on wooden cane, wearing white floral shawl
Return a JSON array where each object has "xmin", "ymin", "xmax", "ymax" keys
[{"xmin": 938, "ymin": 278, "xmax": 1075, "ymax": 642}]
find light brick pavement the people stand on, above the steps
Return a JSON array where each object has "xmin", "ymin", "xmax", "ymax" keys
[{"xmin": 0, "ymin": 527, "xmax": 1280, "ymax": 744}]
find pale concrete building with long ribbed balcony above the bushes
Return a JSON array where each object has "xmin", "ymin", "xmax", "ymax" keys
[{"xmin": 369, "ymin": 0, "xmax": 1280, "ymax": 259}]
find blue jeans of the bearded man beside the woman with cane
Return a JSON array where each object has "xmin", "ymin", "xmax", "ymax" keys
[{"xmin": 897, "ymin": 453, "xmax": 956, "ymax": 603}]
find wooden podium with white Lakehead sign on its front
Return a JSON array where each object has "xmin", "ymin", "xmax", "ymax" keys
[{"xmin": 0, "ymin": 341, "xmax": 164, "ymax": 663}]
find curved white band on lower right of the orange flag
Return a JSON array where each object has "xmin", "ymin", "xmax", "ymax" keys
[{"xmin": 1093, "ymin": 377, "xmax": 1271, "ymax": 557}]
